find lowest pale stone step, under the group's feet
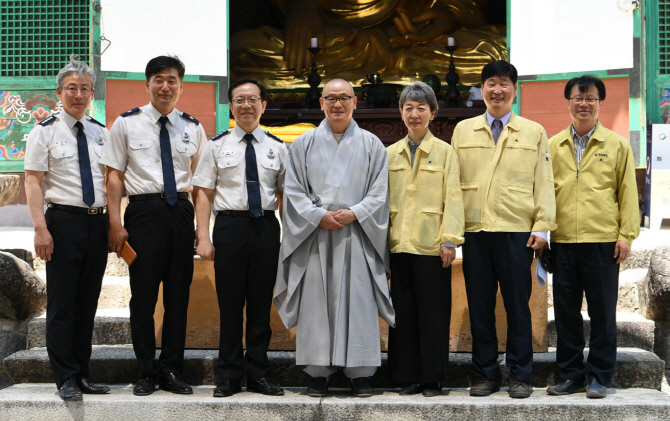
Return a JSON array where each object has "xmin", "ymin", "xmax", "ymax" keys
[{"xmin": 0, "ymin": 384, "xmax": 670, "ymax": 421}]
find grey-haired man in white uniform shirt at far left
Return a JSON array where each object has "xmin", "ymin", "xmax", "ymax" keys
[{"xmin": 25, "ymin": 56, "xmax": 109, "ymax": 401}]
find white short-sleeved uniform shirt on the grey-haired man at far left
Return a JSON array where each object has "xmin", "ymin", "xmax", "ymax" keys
[{"xmin": 25, "ymin": 111, "xmax": 109, "ymax": 208}]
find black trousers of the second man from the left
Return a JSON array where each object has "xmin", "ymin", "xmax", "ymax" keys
[{"xmin": 124, "ymin": 200, "xmax": 195, "ymax": 378}]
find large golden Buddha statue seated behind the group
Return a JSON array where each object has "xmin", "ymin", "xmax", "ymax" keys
[{"xmin": 230, "ymin": 0, "xmax": 507, "ymax": 88}]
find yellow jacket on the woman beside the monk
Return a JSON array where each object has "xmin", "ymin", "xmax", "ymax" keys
[{"xmin": 386, "ymin": 131, "xmax": 463, "ymax": 256}]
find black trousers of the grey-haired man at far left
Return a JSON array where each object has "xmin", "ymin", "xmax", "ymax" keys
[{"xmin": 44, "ymin": 209, "xmax": 109, "ymax": 389}]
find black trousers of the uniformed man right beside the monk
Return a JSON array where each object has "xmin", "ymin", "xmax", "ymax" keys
[{"xmin": 212, "ymin": 214, "xmax": 279, "ymax": 381}]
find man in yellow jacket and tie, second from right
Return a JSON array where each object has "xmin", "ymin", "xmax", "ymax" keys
[{"xmin": 451, "ymin": 60, "xmax": 556, "ymax": 398}]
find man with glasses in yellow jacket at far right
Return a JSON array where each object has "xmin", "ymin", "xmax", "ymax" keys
[{"xmin": 547, "ymin": 75, "xmax": 640, "ymax": 398}]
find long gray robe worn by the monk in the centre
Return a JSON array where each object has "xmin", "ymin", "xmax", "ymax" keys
[{"xmin": 274, "ymin": 120, "xmax": 395, "ymax": 367}]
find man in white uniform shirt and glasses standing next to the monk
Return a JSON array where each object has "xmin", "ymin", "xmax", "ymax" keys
[{"xmin": 193, "ymin": 79, "xmax": 288, "ymax": 397}]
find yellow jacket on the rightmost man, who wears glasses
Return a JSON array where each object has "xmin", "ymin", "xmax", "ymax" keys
[{"xmin": 550, "ymin": 123, "xmax": 640, "ymax": 243}]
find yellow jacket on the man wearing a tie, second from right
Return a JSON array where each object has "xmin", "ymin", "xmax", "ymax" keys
[{"xmin": 451, "ymin": 113, "xmax": 556, "ymax": 232}]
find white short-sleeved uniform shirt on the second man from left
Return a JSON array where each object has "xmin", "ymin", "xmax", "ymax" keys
[{"xmin": 100, "ymin": 103, "xmax": 207, "ymax": 196}]
